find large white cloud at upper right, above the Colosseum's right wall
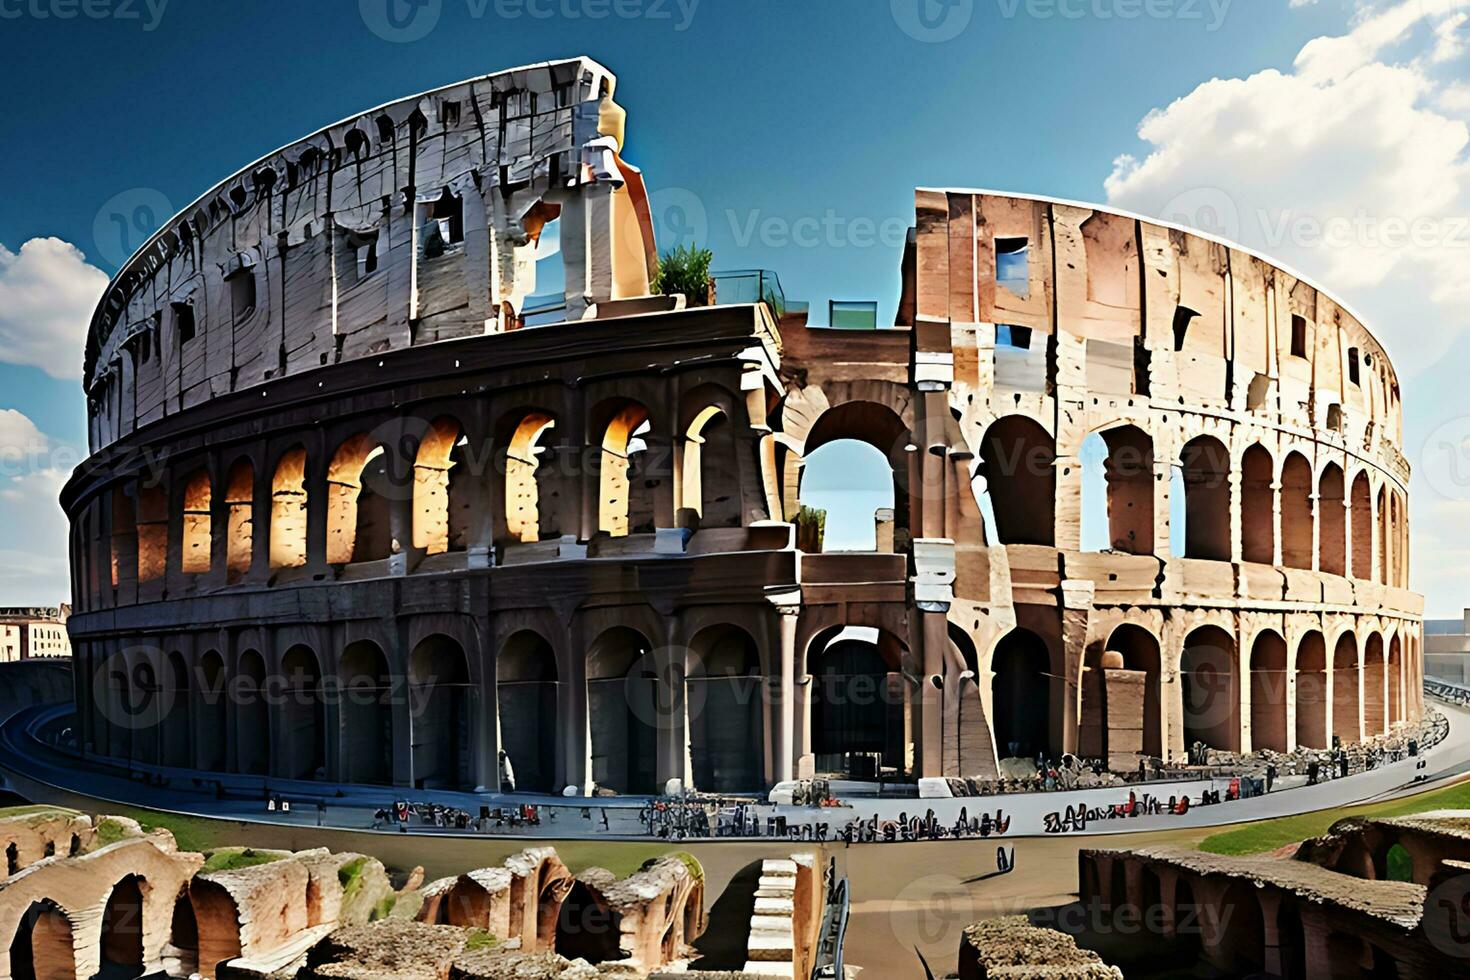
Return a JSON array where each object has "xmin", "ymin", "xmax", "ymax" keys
[{"xmin": 1104, "ymin": 0, "xmax": 1470, "ymax": 373}]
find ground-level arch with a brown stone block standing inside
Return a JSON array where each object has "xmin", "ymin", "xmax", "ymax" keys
[{"xmin": 1078, "ymin": 623, "xmax": 1163, "ymax": 768}]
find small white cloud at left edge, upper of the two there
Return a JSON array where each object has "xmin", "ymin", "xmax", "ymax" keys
[{"xmin": 0, "ymin": 238, "xmax": 107, "ymax": 378}]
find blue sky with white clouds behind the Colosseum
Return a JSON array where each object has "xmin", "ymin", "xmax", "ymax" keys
[{"xmin": 0, "ymin": 0, "xmax": 1470, "ymax": 614}]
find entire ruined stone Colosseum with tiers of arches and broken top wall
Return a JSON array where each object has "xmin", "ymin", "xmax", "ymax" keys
[{"xmin": 63, "ymin": 57, "xmax": 1423, "ymax": 795}]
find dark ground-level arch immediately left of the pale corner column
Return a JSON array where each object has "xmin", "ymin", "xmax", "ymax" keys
[{"xmin": 685, "ymin": 626, "xmax": 764, "ymax": 793}]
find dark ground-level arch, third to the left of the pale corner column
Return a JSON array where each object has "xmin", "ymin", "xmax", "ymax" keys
[{"xmin": 495, "ymin": 630, "xmax": 560, "ymax": 793}]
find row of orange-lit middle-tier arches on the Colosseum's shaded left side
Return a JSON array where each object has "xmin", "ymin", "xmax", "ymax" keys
[{"xmin": 88, "ymin": 383, "xmax": 744, "ymax": 602}]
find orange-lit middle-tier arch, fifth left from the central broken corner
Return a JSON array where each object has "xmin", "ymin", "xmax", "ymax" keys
[{"xmin": 326, "ymin": 433, "xmax": 392, "ymax": 564}]
